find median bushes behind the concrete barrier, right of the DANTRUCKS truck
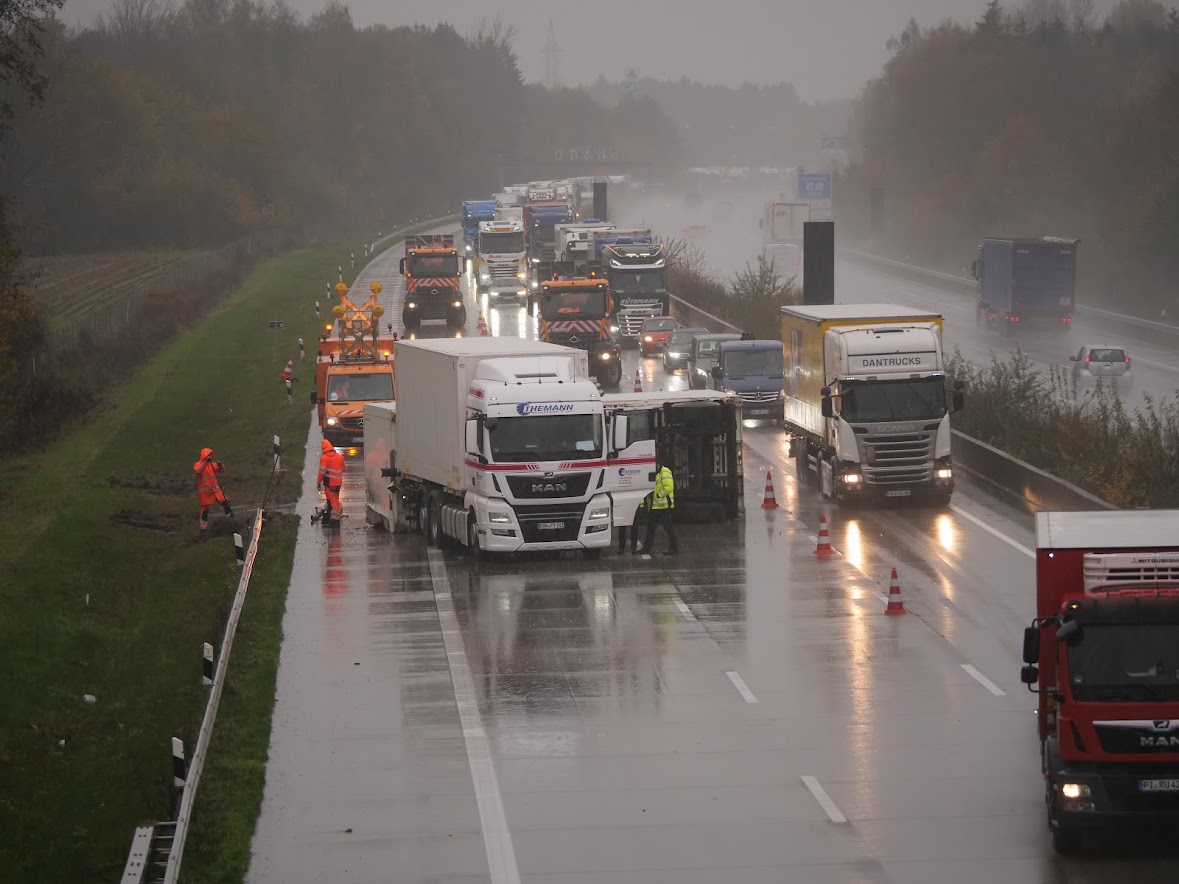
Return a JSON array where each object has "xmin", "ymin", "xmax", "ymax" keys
[{"xmin": 947, "ymin": 351, "xmax": 1179, "ymax": 508}]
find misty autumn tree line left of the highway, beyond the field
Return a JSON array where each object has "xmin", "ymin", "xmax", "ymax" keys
[{"xmin": 0, "ymin": 0, "xmax": 678, "ymax": 441}]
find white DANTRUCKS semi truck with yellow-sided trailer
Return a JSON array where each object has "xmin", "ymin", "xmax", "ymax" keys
[{"xmin": 782, "ymin": 304, "xmax": 963, "ymax": 503}]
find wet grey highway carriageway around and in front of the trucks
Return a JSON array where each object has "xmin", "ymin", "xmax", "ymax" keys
[{"xmin": 241, "ymin": 226, "xmax": 1179, "ymax": 884}]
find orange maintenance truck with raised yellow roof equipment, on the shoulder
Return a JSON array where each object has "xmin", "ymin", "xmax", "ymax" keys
[{"xmin": 311, "ymin": 282, "xmax": 394, "ymax": 448}]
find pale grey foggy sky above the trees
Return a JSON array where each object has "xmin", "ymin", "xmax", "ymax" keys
[{"xmin": 62, "ymin": 0, "xmax": 1131, "ymax": 100}]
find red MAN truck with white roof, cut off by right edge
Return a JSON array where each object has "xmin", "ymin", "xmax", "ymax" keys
[{"xmin": 1021, "ymin": 509, "xmax": 1179, "ymax": 853}]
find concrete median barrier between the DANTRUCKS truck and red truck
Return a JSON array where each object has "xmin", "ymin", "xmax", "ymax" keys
[{"xmin": 950, "ymin": 430, "xmax": 1118, "ymax": 513}]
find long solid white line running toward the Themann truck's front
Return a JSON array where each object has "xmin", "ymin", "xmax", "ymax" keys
[{"xmin": 427, "ymin": 549, "xmax": 520, "ymax": 884}]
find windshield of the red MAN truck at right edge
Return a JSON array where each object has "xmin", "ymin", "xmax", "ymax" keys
[{"xmin": 1068, "ymin": 624, "xmax": 1179, "ymax": 700}]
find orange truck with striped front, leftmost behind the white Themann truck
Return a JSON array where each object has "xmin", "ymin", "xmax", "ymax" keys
[{"xmin": 401, "ymin": 233, "xmax": 467, "ymax": 329}]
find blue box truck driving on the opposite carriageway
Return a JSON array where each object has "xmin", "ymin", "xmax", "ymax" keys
[{"xmin": 970, "ymin": 237, "xmax": 1080, "ymax": 336}]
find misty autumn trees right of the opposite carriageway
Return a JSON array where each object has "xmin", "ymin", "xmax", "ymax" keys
[{"xmin": 836, "ymin": 0, "xmax": 1179, "ymax": 315}]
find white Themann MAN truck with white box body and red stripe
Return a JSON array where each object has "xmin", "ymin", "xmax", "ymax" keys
[{"xmin": 364, "ymin": 337, "xmax": 626, "ymax": 555}]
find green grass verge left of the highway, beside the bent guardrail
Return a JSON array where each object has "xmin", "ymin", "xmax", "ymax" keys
[{"xmin": 0, "ymin": 248, "xmax": 349, "ymax": 884}]
